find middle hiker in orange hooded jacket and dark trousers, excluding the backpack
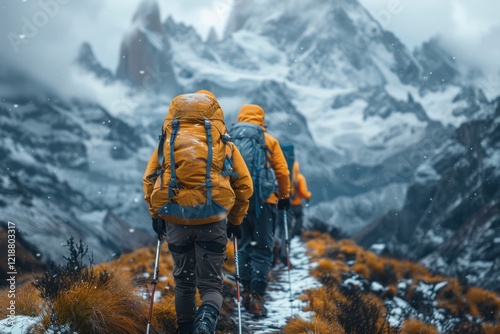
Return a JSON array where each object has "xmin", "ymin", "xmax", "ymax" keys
[{"xmin": 233, "ymin": 104, "xmax": 290, "ymax": 317}]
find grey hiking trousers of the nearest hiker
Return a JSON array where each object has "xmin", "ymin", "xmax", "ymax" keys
[{"xmin": 166, "ymin": 219, "xmax": 227, "ymax": 323}]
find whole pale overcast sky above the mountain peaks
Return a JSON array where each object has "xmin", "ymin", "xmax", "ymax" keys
[{"xmin": 0, "ymin": 0, "xmax": 500, "ymax": 90}]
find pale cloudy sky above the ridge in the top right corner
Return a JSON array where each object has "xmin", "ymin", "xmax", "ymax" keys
[{"xmin": 360, "ymin": 0, "xmax": 500, "ymax": 72}]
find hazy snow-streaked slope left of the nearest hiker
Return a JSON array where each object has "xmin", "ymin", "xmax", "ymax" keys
[{"xmin": 0, "ymin": 66, "xmax": 152, "ymax": 261}]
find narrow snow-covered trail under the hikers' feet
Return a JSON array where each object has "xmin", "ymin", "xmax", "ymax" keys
[{"xmin": 230, "ymin": 237, "xmax": 321, "ymax": 334}]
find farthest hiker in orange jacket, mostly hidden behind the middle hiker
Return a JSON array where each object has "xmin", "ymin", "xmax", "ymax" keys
[{"xmin": 290, "ymin": 161, "xmax": 312, "ymax": 237}]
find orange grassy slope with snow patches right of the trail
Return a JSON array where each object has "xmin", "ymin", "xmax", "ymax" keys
[{"xmin": 284, "ymin": 233, "xmax": 500, "ymax": 334}]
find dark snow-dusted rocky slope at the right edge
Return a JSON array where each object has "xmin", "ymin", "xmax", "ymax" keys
[{"xmin": 357, "ymin": 99, "xmax": 500, "ymax": 291}]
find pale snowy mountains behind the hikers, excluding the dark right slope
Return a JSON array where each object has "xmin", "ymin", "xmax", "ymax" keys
[{"xmin": 0, "ymin": 0, "xmax": 495, "ymax": 276}]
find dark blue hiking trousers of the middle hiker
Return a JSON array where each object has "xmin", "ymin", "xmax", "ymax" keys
[{"xmin": 238, "ymin": 203, "xmax": 276, "ymax": 296}]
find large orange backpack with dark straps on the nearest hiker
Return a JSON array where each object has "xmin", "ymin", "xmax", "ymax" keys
[{"xmin": 149, "ymin": 94, "xmax": 235, "ymax": 225}]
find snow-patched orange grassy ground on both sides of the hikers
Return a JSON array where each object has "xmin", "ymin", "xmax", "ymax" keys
[{"xmin": 0, "ymin": 232, "xmax": 500, "ymax": 334}]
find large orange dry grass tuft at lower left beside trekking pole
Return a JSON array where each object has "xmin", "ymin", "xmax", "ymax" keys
[{"xmin": 40, "ymin": 268, "xmax": 148, "ymax": 334}]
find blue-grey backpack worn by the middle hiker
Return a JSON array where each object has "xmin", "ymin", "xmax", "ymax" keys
[{"xmin": 229, "ymin": 122, "xmax": 276, "ymax": 217}]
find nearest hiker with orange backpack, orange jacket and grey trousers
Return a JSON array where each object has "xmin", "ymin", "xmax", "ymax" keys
[{"xmin": 143, "ymin": 91, "xmax": 253, "ymax": 333}]
